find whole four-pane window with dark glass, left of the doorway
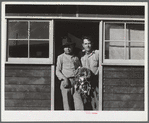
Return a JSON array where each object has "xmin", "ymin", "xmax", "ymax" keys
[{"xmin": 7, "ymin": 20, "xmax": 53, "ymax": 63}]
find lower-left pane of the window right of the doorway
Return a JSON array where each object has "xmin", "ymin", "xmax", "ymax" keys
[{"xmin": 105, "ymin": 42, "xmax": 124, "ymax": 59}]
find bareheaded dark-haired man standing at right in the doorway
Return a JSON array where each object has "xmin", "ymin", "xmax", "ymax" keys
[{"xmin": 81, "ymin": 36, "xmax": 99, "ymax": 110}]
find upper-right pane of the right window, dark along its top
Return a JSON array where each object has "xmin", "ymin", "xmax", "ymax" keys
[{"xmin": 127, "ymin": 24, "xmax": 144, "ymax": 41}]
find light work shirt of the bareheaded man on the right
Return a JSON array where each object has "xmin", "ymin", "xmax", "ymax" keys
[{"xmin": 81, "ymin": 50, "xmax": 99, "ymax": 75}]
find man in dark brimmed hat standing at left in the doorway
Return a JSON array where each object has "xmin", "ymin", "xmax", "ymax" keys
[{"xmin": 56, "ymin": 37, "xmax": 84, "ymax": 110}]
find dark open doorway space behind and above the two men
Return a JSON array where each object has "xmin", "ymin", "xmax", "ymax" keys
[{"xmin": 54, "ymin": 20, "xmax": 99, "ymax": 110}]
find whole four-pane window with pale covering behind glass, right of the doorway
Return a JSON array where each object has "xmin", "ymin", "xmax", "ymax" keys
[{"xmin": 103, "ymin": 22, "xmax": 145, "ymax": 63}]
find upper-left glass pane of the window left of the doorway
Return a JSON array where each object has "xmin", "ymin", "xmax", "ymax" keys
[{"xmin": 8, "ymin": 22, "xmax": 28, "ymax": 39}]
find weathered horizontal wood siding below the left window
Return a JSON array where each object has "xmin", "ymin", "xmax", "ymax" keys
[{"xmin": 5, "ymin": 65, "xmax": 51, "ymax": 110}]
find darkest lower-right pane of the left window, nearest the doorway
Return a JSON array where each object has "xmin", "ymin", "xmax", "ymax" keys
[{"xmin": 30, "ymin": 41, "xmax": 49, "ymax": 58}]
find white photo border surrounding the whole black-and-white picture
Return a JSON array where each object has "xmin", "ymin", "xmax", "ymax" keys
[{"xmin": 1, "ymin": 2, "xmax": 148, "ymax": 122}]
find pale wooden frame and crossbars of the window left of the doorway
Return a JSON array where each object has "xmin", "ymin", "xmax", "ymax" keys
[{"xmin": 5, "ymin": 19, "xmax": 54, "ymax": 64}]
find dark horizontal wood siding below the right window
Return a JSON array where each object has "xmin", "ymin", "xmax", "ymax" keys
[{"xmin": 103, "ymin": 66, "xmax": 144, "ymax": 111}]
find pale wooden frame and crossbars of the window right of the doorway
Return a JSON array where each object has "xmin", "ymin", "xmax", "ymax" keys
[{"xmin": 102, "ymin": 20, "xmax": 146, "ymax": 66}]
